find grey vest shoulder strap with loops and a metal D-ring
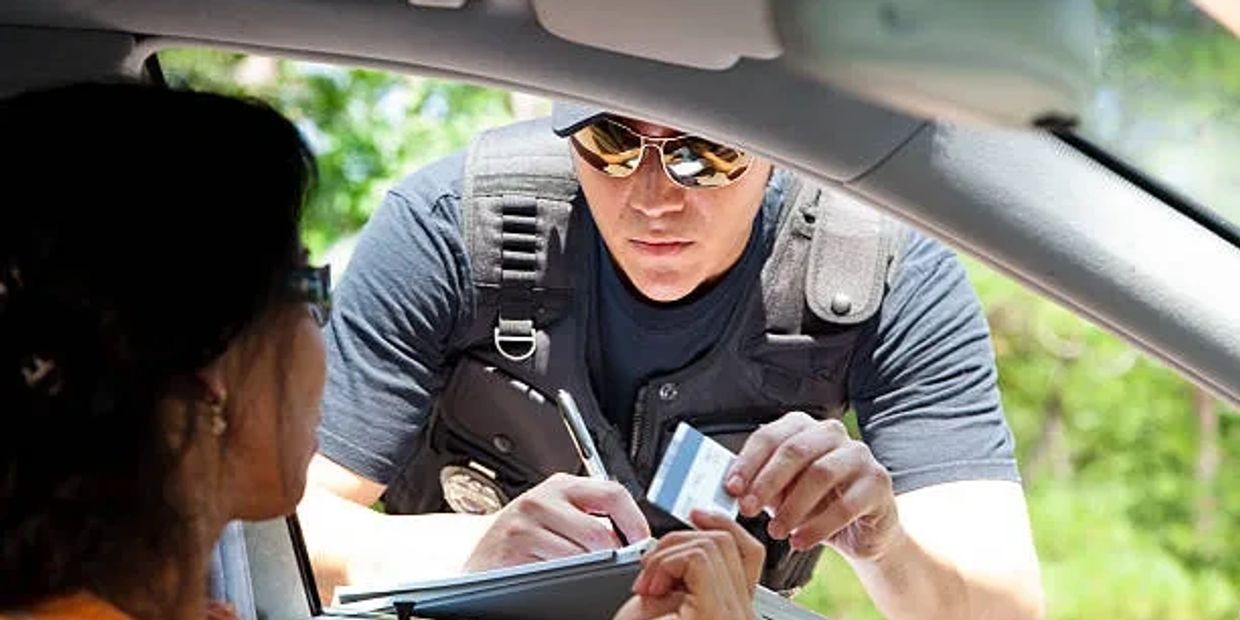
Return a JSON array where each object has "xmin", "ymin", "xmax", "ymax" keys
[{"xmin": 461, "ymin": 119, "xmax": 579, "ymax": 362}]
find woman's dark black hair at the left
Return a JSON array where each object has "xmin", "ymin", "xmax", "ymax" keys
[{"xmin": 0, "ymin": 79, "xmax": 314, "ymax": 610}]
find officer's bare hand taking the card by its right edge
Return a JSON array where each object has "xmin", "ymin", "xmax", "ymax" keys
[{"xmin": 725, "ymin": 412, "xmax": 900, "ymax": 559}]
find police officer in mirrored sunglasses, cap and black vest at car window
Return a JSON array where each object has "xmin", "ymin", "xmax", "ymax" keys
[{"xmin": 299, "ymin": 104, "xmax": 1042, "ymax": 618}]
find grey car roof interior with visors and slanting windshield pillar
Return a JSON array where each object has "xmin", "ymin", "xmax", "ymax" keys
[{"xmin": 0, "ymin": 0, "xmax": 1240, "ymax": 404}]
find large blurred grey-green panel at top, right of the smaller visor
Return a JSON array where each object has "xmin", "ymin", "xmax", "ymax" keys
[{"xmin": 771, "ymin": 0, "xmax": 1097, "ymax": 126}]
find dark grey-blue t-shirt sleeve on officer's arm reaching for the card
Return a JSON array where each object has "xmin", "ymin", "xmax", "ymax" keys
[{"xmin": 849, "ymin": 232, "xmax": 1019, "ymax": 494}]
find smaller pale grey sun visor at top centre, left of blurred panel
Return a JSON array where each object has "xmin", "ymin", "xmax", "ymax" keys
[{"xmin": 532, "ymin": 0, "xmax": 781, "ymax": 69}]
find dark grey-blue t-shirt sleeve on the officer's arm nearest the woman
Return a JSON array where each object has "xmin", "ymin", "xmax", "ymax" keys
[{"xmin": 319, "ymin": 157, "xmax": 472, "ymax": 485}]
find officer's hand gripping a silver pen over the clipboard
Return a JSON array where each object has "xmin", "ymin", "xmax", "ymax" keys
[{"xmin": 465, "ymin": 474, "xmax": 650, "ymax": 572}]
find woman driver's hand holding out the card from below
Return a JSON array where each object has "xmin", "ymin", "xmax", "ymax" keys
[{"xmin": 614, "ymin": 511, "xmax": 766, "ymax": 620}]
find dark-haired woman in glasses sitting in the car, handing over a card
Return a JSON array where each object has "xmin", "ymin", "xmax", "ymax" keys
[{"xmin": 0, "ymin": 84, "xmax": 763, "ymax": 620}]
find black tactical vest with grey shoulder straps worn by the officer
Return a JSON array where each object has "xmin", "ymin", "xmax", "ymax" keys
[{"xmin": 384, "ymin": 120, "xmax": 900, "ymax": 590}]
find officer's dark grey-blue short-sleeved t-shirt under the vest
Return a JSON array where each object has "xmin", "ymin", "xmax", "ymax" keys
[{"xmin": 319, "ymin": 153, "xmax": 1019, "ymax": 492}]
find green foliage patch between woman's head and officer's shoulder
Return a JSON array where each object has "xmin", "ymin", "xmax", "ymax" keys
[{"xmin": 159, "ymin": 50, "xmax": 513, "ymax": 254}]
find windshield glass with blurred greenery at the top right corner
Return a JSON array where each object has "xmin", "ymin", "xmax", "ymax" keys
[{"xmin": 1078, "ymin": 0, "xmax": 1240, "ymax": 224}]
